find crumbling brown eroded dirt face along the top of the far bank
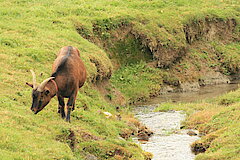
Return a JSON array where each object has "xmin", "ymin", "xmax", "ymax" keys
[{"xmin": 75, "ymin": 17, "xmax": 239, "ymax": 68}]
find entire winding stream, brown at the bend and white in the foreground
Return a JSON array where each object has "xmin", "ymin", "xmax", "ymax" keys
[{"xmin": 134, "ymin": 83, "xmax": 238, "ymax": 160}]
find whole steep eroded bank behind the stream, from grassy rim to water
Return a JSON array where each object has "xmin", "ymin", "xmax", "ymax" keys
[{"xmin": 79, "ymin": 15, "xmax": 240, "ymax": 103}]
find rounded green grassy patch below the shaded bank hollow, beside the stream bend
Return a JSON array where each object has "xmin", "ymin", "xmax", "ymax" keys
[{"xmin": 111, "ymin": 62, "xmax": 163, "ymax": 103}]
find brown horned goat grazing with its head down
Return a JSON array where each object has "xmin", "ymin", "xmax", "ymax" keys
[{"xmin": 26, "ymin": 46, "xmax": 86, "ymax": 122}]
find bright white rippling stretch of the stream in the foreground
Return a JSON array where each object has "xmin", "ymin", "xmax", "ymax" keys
[{"xmin": 136, "ymin": 111, "xmax": 199, "ymax": 160}]
